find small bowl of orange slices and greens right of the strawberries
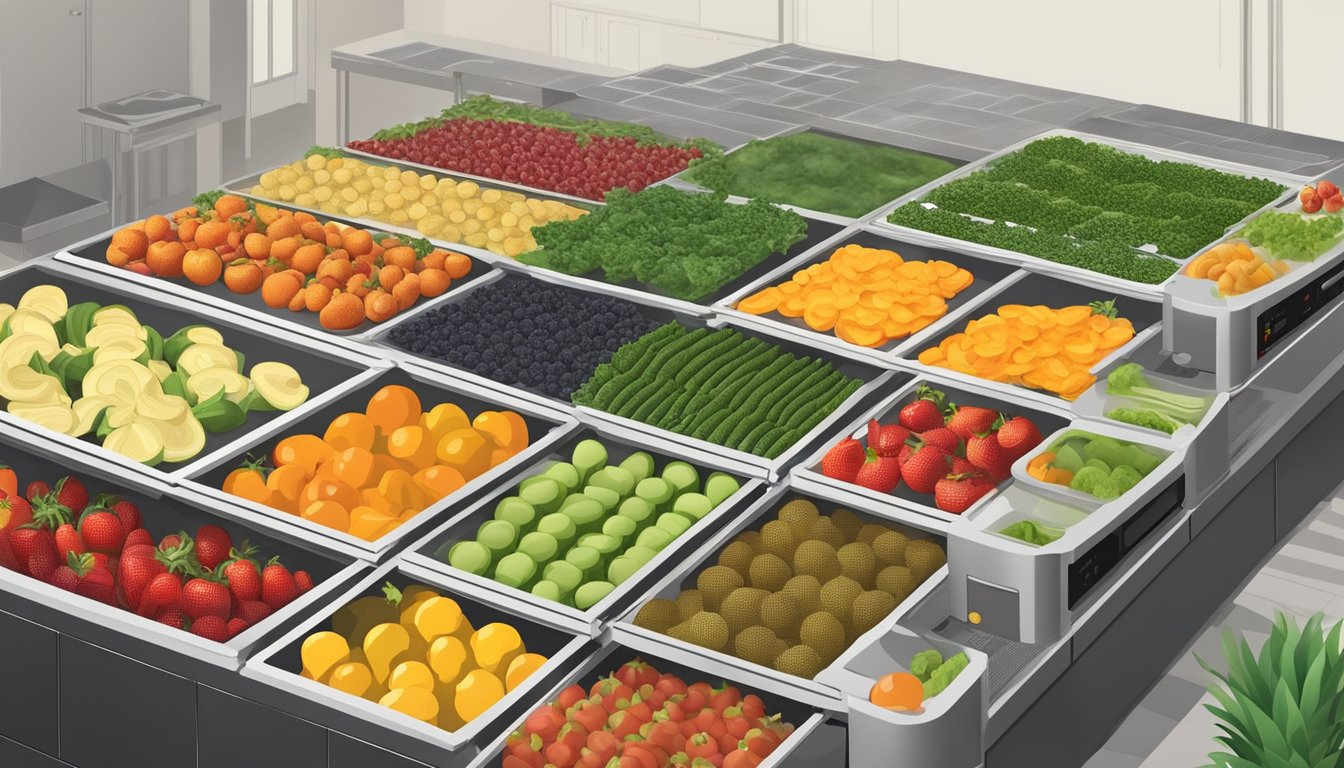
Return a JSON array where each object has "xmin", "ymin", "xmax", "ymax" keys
[{"xmin": 1000, "ymin": 428, "xmax": 1172, "ymax": 511}]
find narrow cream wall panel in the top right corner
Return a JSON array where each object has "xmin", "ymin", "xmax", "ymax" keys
[{"xmin": 1281, "ymin": 0, "xmax": 1344, "ymax": 140}]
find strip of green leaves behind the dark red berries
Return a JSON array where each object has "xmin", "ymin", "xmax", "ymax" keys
[{"xmin": 372, "ymin": 94, "xmax": 723, "ymax": 157}]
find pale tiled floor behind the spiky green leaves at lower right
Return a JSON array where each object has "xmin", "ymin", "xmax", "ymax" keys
[{"xmin": 1085, "ymin": 486, "xmax": 1344, "ymax": 768}]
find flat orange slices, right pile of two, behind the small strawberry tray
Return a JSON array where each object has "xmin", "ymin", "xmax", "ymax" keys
[{"xmin": 919, "ymin": 301, "xmax": 1134, "ymax": 399}]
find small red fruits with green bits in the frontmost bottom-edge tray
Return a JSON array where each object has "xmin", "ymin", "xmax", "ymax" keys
[{"xmin": 503, "ymin": 659, "xmax": 793, "ymax": 768}]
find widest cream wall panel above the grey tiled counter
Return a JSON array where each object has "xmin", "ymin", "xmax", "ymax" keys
[{"xmin": 897, "ymin": 0, "xmax": 1241, "ymax": 120}]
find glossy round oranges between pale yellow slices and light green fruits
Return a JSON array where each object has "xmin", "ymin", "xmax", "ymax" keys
[{"xmin": 223, "ymin": 385, "xmax": 528, "ymax": 541}]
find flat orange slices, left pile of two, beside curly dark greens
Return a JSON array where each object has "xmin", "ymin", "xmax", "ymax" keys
[{"xmin": 738, "ymin": 243, "xmax": 974, "ymax": 347}]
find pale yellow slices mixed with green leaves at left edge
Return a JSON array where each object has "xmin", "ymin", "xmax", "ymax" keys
[{"xmin": 0, "ymin": 285, "xmax": 309, "ymax": 467}]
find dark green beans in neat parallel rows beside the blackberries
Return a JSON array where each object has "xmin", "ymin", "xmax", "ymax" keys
[{"xmin": 573, "ymin": 323, "xmax": 863, "ymax": 459}]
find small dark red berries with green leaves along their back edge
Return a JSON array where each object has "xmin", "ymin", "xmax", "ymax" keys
[{"xmin": 349, "ymin": 95, "xmax": 720, "ymax": 200}]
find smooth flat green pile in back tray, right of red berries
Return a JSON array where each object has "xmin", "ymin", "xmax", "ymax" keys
[{"xmin": 681, "ymin": 130, "xmax": 954, "ymax": 218}]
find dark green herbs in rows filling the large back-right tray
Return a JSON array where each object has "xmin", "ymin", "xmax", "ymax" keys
[{"xmin": 890, "ymin": 136, "xmax": 1285, "ymax": 282}]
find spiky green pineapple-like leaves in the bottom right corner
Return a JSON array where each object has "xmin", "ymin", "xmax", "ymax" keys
[{"xmin": 1196, "ymin": 613, "xmax": 1344, "ymax": 768}]
